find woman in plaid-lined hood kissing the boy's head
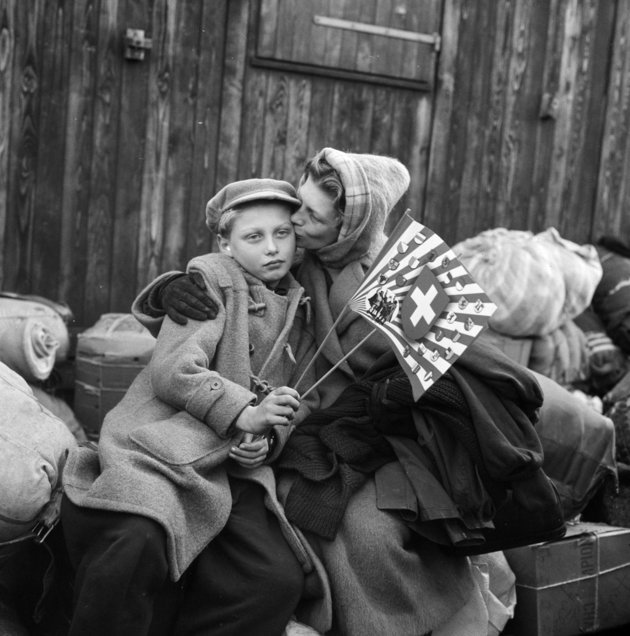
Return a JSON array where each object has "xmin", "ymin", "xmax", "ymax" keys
[{"xmin": 142, "ymin": 148, "xmax": 487, "ymax": 636}]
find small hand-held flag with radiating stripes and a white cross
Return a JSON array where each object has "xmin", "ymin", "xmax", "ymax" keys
[{"xmin": 348, "ymin": 213, "xmax": 497, "ymax": 400}]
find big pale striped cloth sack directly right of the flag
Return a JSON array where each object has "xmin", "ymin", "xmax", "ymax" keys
[{"xmin": 453, "ymin": 228, "xmax": 601, "ymax": 337}]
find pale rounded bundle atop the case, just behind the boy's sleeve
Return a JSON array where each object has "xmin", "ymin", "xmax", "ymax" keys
[{"xmin": 77, "ymin": 314, "xmax": 155, "ymax": 362}]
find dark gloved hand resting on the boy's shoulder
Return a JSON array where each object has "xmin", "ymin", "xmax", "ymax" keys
[{"xmin": 160, "ymin": 272, "xmax": 217, "ymax": 325}]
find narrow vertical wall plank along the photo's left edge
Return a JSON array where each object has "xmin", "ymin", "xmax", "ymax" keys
[{"xmin": 0, "ymin": 0, "xmax": 16, "ymax": 289}]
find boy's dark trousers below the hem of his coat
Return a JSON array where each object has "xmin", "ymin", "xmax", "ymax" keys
[{"xmin": 62, "ymin": 478, "xmax": 304, "ymax": 636}]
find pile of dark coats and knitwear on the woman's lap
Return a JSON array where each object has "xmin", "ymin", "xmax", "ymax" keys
[{"xmin": 278, "ymin": 343, "xmax": 565, "ymax": 555}]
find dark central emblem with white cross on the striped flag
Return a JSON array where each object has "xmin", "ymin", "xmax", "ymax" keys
[{"xmin": 400, "ymin": 266, "xmax": 449, "ymax": 341}]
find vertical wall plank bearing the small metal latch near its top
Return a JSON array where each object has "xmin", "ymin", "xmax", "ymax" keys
[{"xmin": 110, "ymin": 0, "xmax": 152, "ymax": 312}]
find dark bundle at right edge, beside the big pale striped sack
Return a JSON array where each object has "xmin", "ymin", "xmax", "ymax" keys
[{"xmin": 593, "ymin": 245, "xmax": 630, "ymax": 355}]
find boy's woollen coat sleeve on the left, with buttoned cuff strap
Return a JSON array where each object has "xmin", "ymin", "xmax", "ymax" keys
[{"xmin": 149, "ymin": 288, "xmax": 256, "ymax": 438}]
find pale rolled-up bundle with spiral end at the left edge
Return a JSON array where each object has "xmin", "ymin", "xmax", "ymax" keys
[{"xmin": 0, "ymin": 297, "xmax": 70, "ymax": 382}]
